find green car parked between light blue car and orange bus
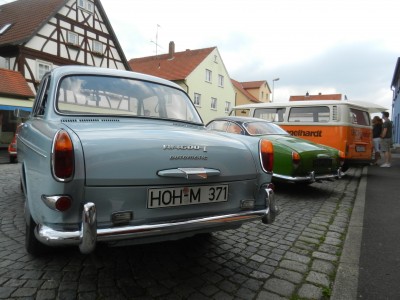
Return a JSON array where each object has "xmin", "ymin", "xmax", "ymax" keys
[{"xmin": 207, "ymin": 116, "xmax": 344, "ymax": 183}]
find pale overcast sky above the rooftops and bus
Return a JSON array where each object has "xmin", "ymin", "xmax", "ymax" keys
[{"xmin": 101, "ymin": 0, "xmax": 400, "ymax": 109}]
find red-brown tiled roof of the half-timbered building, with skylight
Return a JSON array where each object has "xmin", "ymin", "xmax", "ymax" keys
[{"xmin": 0, "ymin": 0, "xmax": 67, "ymax": 45}]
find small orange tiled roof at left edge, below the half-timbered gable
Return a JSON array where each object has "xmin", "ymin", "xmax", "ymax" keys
[{"xmin": 0, "ymin": 68, "xmax": 35, "ymax": 97}]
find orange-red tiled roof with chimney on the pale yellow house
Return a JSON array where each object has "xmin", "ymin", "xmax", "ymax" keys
[{"xmin": 129, "ymin": 47, "xmax": 216, "ymax": 80}]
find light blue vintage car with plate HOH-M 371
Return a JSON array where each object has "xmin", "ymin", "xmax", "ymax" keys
[{"xmin": 16, "ymin": 66, "xmax": 278, "ymax": 255}]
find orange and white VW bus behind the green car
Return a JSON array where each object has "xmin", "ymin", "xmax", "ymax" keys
[{"xmin": 230, "ymin": 100, "xmax": 386, "ymax": 170}]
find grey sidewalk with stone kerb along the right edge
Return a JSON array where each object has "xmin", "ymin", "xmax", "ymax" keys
[{"xmin": 331, "ymin": 149, "xmax": 400, "ymax": 300}]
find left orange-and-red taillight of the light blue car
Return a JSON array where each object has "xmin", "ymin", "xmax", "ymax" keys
[{"xmin": 52, "ymin": 130, "xmax": 74, "ymax": 181}]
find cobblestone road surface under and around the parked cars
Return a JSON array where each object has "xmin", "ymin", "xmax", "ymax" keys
[{"xmin": 0, "ymin": 154, "xmax": 362, "ymax": 299}]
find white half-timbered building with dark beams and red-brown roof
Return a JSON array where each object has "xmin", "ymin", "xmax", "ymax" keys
[{"xmin": 0, "ymin": 0, "xmax": 130, "ymax": 94}]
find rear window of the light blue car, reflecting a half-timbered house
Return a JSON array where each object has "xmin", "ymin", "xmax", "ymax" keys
[{"xmin": 56, "ymin": 75, "xmax": 202, "ymax": 123}]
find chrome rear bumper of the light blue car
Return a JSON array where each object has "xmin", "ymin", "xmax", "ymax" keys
[{"xmin": 35, "ymin": 188, "xmax": 278, "ymax": 254}]
